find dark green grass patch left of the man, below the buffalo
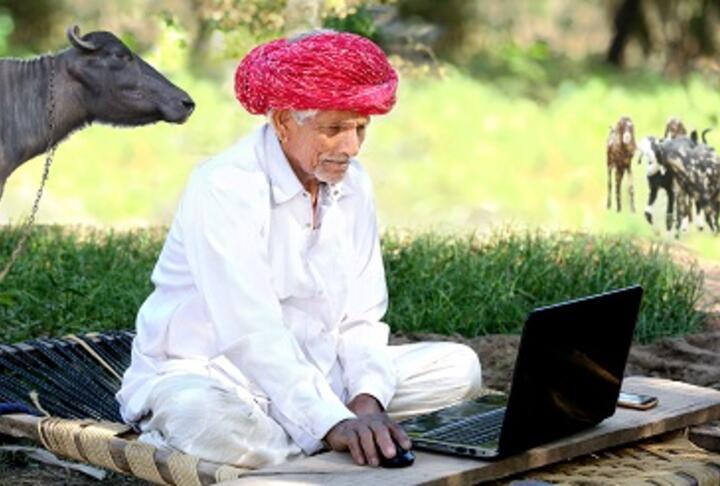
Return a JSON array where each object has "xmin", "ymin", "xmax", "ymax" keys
[{"xmin": 0, "ymin": 226, "xmax": 165, "ymax": 342}]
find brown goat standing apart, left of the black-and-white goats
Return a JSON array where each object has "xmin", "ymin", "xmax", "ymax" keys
[{"xmin": 607, "ymin": 116, "xmax": 637, "ymax": 212}]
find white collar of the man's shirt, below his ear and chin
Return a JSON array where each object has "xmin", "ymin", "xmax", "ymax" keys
[{"xmin": 264, "ymin": 123, "xmax": 354, "ymax": 204}]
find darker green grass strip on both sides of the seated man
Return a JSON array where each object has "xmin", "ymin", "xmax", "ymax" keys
[{"xmin": 0, "ymin": 226, "xmax": 704, "ymax": 342}]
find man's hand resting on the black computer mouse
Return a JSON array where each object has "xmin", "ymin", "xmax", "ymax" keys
[{"xmin": 324, "ymin": 412, "xmax": 412, "ymax": 466}]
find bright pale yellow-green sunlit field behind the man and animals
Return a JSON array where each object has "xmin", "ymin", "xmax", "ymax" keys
[{"xmin": 0, "ymin": 42, "xmax": 720, "ymax": 259}]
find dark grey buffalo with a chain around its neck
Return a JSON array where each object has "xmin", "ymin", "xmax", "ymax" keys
[{"xmin": 0, "ymin": 26, "xmax": 195, "ymax": 197}]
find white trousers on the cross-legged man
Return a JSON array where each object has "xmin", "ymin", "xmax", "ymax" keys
[{"xmin": 140, "ymin": 342, "xmax": 481, "ymax": 468}]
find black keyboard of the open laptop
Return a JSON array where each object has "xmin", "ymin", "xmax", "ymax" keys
[{"xmin": 422, "ymin": 407, "xmax": 505, "ymax": 445}]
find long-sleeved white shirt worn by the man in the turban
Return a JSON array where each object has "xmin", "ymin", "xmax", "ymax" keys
[{"xmin": 117, "ymin": 124, "xmax": 395, "ymax": 453}]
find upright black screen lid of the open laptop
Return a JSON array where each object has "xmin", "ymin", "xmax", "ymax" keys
[{"xmin": 500, "ymin": 286, "xmax": 642, "ymax": 455}]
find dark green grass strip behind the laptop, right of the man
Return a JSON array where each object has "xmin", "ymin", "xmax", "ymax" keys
[{"xmin": 383, "ymin": 230, "xmax": 704, "ymax": 342}]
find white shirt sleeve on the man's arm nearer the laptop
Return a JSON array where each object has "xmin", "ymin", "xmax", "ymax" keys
[{"xmin": 338, "ymin": 173, "xmax": 396, "ymax": 408}]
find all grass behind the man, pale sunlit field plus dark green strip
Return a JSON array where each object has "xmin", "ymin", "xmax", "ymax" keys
[{"xmin": 0, "ymin": 30, "xmax": 720, "ymax": 341}]
